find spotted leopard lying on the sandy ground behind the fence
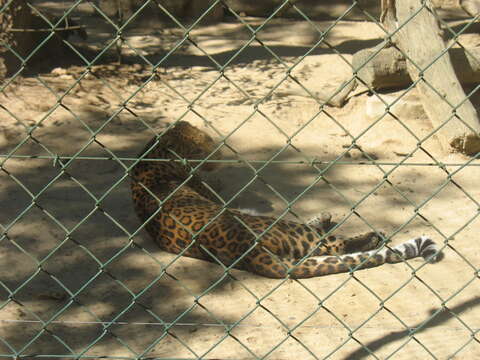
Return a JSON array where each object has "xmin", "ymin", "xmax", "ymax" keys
[{"xmin": 130, "ymin": 121, "xmax": 440, "ymax": 279}]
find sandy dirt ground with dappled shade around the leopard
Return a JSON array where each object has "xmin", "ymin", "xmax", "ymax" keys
[{"xmin": 0, "ymin": 2, "xmax": 480, "ymax": 360}]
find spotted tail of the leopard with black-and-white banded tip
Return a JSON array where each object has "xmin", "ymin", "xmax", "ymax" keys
[{"xmin": 252, "ymin": 236, "xmax": 442, "ymax": 279}]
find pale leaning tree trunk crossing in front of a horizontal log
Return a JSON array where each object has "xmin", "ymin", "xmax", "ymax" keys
[{"xmin": 381, "ymin": 0, "xmax": 480, "ymax": 155}]
